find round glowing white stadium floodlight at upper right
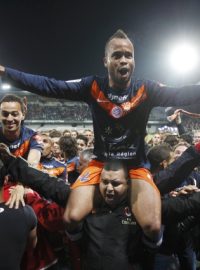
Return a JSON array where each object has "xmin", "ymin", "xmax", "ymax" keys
[{"xmin": 169, "ymin": 42, "xmax": 199, "ymax": 75}]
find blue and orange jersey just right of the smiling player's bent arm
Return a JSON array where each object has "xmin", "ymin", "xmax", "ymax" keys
[{"xmin": 38, "ymin": 157, "xmax": 67, "ymax": 181}]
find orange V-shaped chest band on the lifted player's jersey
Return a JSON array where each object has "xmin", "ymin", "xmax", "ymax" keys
[{"xmin": 91, "ymin": 81, "xmax": 147, "ymax": 118}]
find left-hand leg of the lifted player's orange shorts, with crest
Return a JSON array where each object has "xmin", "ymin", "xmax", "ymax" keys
[{"xmin": 71, "ymin": 160, "xmax": 104, "ymax": 189}]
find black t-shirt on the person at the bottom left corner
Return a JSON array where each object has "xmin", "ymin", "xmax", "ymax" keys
[{"xmin": 0, "ymin": 203, "xmax": 37, "ymax": 270}]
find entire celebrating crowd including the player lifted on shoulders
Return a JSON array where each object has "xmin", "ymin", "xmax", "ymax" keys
[{"xmin": 0, "ymin": 30, "xmax": 200, "ymax": 270}]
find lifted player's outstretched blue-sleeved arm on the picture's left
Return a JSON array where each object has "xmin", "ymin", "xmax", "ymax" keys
[{"xmin": 0, "ymin": 66, "xmax": 92, "ymax": 101}]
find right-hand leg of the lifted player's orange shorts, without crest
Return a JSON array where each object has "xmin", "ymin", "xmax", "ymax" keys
[{"xmin": 129, "ymin": 168, "xmax": 160, "ymax": 193}]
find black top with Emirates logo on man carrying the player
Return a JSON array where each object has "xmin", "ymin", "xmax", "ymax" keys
[{"xmin": 83, "ymin": 202, "xmax": 142, "ymax": 270}]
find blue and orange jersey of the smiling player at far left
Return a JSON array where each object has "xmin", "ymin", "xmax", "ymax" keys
[{"xmin": 0, "ymin": 125, "xmax": 43, "ymax": 159}]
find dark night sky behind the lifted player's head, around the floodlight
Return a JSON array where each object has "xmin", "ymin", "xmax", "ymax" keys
[{"xmin": 0, "ymin": 0, "xmax": 200, "ymax": 83}]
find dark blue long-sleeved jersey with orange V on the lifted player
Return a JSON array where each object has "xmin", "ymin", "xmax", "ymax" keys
[{"xmin": 3, "ymin": 68, "xmax": 200, "ymax": 167}]
